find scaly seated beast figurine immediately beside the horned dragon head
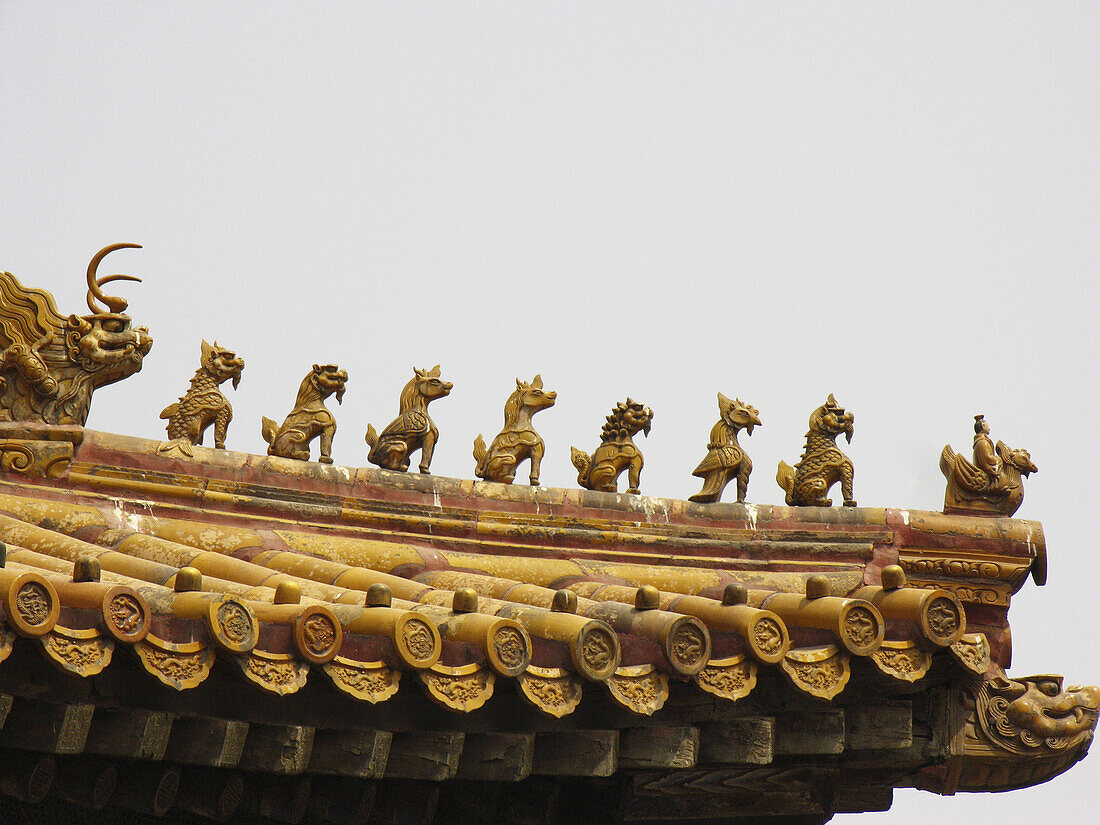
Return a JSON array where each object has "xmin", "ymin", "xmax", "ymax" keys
[{"xmin": 157, "ymin": 341, "xmax": 244, "ymax": 455}]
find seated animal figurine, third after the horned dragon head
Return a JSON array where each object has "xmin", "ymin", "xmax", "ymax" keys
[{"xmin": 366, "ymin": 364, "xmax": 454, "ymax": 474}]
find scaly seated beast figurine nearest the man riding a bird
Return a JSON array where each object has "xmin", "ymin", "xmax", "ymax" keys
[{"xmin": 776, "ymin": 393, "xmax": 856, "ymax": 507}]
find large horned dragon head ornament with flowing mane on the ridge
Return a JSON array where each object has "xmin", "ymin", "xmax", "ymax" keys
[{"xmin": 0, "ymin": 243, "xmax": 153, "ymax": 427}]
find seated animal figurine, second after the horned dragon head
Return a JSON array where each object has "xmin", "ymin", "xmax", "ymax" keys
[{"xmin": 261, "ymin": 364, "xmax": 348, "ymax": 464}]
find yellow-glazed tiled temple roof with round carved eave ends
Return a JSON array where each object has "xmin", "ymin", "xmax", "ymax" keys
[{"xmin": 0, "ymin": 424, "xmax": 1086, "ymax": 822}]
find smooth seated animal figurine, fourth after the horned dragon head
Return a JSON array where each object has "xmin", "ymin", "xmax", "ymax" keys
[{"xmin": 474, "ymin": 375, "xmax": 558, "ymax": 487}]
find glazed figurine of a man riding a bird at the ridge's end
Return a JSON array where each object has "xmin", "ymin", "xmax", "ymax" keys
[{"xmin": 939, "ymin": 416, "xmax": 1038, "ymax": 516}]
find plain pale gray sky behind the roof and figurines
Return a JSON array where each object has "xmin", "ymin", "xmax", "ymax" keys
[{"xmin": 0, "ymin": 0, "xmax": 1100, "ymax": 825}]
